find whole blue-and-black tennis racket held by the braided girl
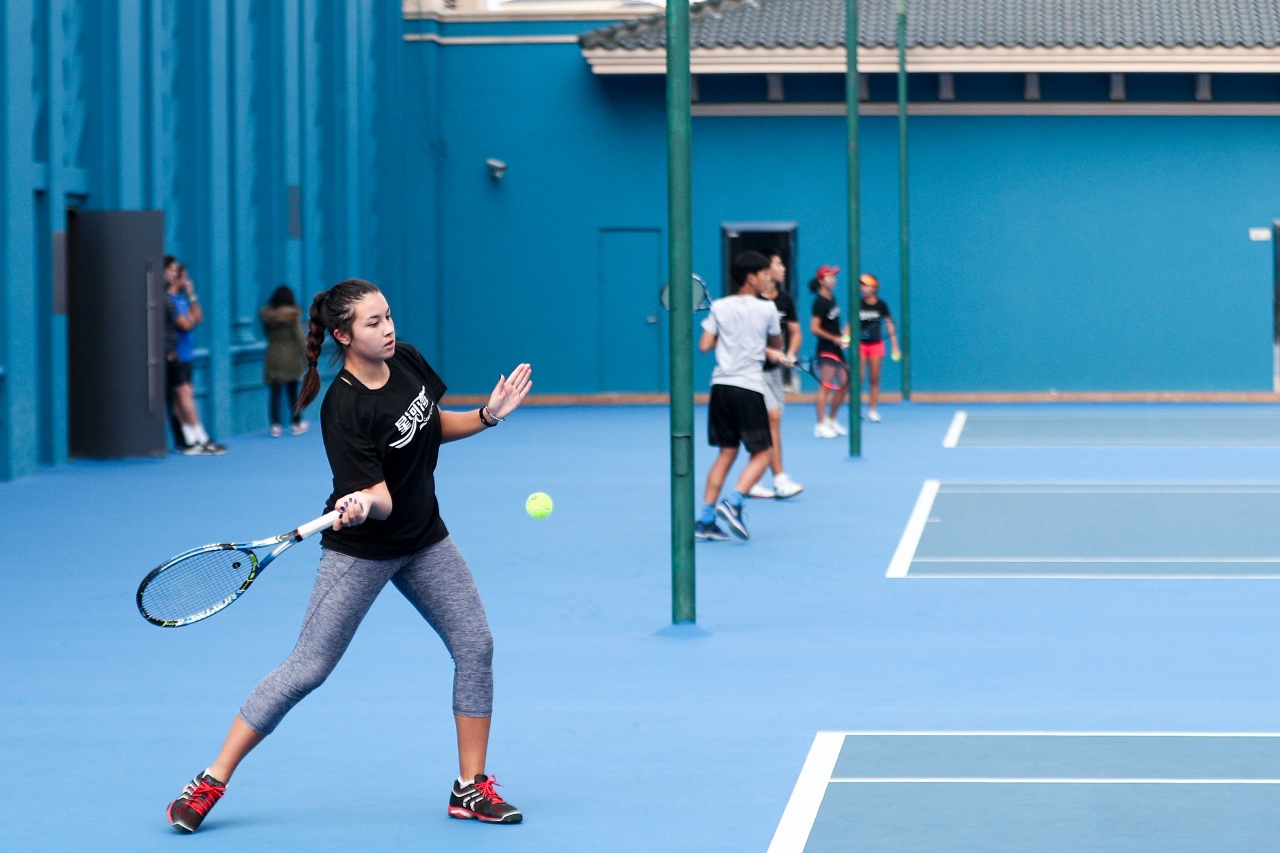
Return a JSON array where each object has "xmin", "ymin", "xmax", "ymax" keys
[{"xmin": 138, "ymin": 510, "xmax": 338, "ymax": 628}]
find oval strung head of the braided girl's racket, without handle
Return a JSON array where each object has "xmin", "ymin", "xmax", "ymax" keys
[{"xmin": 140, "ymin": 549, "xmax": 257, "ymax": 621}]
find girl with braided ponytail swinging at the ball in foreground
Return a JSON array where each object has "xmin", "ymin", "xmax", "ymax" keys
[{"xmin": 168, "ymin": 279, "xmax": 532, "ymax": 833}]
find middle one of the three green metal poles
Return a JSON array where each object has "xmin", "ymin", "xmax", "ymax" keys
[{"xmin": 845, "ymin": 0, "xmax": 863, "ymax": 456}]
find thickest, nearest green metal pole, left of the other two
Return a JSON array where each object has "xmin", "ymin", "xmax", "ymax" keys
[{"xmin": 667, "ymin": 0, "xmax": 698, "ymax": 625}]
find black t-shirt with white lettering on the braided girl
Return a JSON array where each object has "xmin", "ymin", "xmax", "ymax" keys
[{"xmin": 320, "ymin": 341, "xmax": 449, "ymax": 560}]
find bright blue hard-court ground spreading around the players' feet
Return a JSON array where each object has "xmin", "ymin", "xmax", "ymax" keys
[{"xmin": 0, "ymin": 398, "xmax": 1280, "ymax": 853}]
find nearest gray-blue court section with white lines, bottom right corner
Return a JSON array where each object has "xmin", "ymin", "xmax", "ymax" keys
[{"xmin": 768, "ymin": 731, "xmax": 1280, "ymax": 853}]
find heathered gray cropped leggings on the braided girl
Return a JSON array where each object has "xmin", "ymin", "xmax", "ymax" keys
[{"xmin": 239, "ymin": 537, "xmax": 493, "ymax": 735}]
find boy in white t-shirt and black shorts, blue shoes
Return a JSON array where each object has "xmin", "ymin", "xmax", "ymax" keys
[{"xmin": 694, "ymin": 251, "xmax": 785, "ymax": 540}]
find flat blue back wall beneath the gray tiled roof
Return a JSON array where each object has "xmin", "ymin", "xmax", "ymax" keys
[{"xmin": 434, "ymin": 24, "xmax": 1280, "ymax": 392}]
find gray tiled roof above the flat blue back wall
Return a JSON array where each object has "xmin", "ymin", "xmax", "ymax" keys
[{"xmin": 579, "ymin": 0, "xmax": 1280, "ymax": 50}]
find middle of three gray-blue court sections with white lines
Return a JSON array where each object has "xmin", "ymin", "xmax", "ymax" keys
[{"xmin": 887, "ymin": 480, "xmax": 1280, "ymax": 578}]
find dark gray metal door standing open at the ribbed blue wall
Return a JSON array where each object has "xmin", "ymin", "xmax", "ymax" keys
[{"xmin": 67, "ymin": 210, "xmax": 165, "ymax": 459}]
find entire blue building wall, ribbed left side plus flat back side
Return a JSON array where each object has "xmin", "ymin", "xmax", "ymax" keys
[{"xmin": 0, "ymin": 0, "xmax": 1280, "ymax": 478}]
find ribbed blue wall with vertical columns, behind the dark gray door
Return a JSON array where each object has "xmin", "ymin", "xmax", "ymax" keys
[{"xmin": 0, "ymin": 0, "xmax": 409, "ymax": 479}]
